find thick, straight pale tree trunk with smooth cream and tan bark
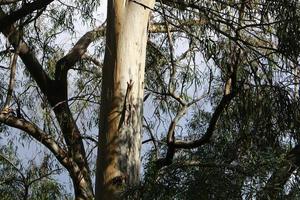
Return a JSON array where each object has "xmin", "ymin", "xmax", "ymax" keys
[{"xmin": 96, "ymin": 0, "xmax": 155, "ymax": 200}]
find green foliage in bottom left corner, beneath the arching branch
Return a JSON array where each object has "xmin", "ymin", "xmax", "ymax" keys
[{"xmin": 0, "ymin": 145, "xmax": 71, "ymax": 200}]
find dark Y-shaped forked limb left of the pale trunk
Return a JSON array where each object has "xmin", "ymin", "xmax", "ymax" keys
[{"xmin": 0, "ymin": 8, "xmax": 95, "ymax": 198}]
